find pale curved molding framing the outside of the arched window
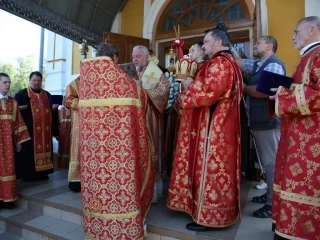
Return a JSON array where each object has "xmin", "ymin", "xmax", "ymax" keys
[{"xmin": 143, "ymin": 0, "xmax": 255, "ymax": 41}]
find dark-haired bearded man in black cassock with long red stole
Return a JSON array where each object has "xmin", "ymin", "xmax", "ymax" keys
[{"xmin": 15, "ymin": 71, "xmax": 59, "ymax": 181}]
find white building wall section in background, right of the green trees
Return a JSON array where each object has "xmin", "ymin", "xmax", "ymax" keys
[{"xmin": 45, "ymin": 32, "xmax": 70, "ymax": 94}]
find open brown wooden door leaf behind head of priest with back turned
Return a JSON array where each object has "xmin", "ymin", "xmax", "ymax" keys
[{"xmin": 103, "ymin": 32, "xmax": 150, "ymax": 63}]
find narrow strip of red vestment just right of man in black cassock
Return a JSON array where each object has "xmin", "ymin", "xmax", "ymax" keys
[{"xmin": 58, "ymin": 107, "xmax": 71, "ymax": 169}]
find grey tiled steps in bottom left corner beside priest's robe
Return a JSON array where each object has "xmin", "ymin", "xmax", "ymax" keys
[{"xmin": 0, "ymin": 190, "xmax": 84, "ymax": 240}]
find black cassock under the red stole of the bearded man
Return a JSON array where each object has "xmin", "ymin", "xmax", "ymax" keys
[{"xmin": 15, "ymin": 89, "xmax": 59, "ymax": 181}]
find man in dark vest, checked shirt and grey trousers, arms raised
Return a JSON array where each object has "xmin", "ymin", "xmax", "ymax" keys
[{"xmin": 233, "ymin": 36, "xmax": 286, "ymax": 218}]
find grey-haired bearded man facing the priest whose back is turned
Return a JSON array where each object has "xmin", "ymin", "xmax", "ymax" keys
[{"xmin": 132, "ymin": 45, "xmax": 171, "ymax": 203}]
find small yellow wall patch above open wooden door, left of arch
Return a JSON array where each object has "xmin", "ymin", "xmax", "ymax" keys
[{"xmin": 121, "ymin": 0, "xmax": 144, "ymax": 37}]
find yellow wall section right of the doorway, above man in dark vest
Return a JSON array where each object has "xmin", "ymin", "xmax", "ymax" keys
[{"xmin": 266, "ymin": 0, "xmax": 305, "ymax": 76}]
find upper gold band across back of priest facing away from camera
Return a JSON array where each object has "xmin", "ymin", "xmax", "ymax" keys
[{"xmin": 79, "ymin": 98, "xmax": 141, "ymax": 107}]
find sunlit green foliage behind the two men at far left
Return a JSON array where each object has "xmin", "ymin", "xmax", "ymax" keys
[{"xmin": 0, "ymin": 56, "xmax": 46, "ymax": 96}]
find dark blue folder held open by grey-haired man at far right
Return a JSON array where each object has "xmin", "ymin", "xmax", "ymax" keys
[{"xmin": 256, "ymin": 70, "xmax": 293, "ymax": 96}]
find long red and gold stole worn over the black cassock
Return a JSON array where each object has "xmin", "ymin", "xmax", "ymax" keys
[{"xmin": 27, "ymin": 88, "xmax": 53, "ymax": 172}]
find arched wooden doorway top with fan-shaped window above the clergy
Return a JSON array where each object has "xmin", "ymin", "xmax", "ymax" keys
[{"xmin": 149, "ymin": 0, "xmax": 254, "ymax": 65}]
